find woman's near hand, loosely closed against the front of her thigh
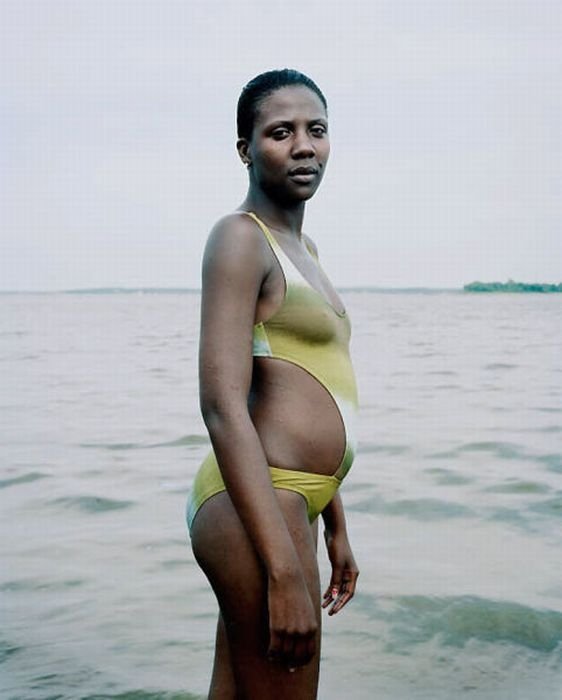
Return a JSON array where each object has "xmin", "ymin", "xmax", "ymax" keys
[{"xmin": 267, "ymin": 572, "xmax": 318, "ymax": 669}]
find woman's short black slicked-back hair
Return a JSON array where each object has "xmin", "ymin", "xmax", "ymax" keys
[{"xmin": 236, "ymin": 68, "xmax": 328, "ymax": 139}]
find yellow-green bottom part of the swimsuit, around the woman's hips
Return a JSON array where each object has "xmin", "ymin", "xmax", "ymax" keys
[{"xmin": 187, "ymin": 451, "xmax": 342, "ymax": 532}]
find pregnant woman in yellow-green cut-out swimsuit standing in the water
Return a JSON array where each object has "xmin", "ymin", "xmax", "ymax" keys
[{"xmin": 188, "ymin": 69, "xmax": 358, "ymax": 700}]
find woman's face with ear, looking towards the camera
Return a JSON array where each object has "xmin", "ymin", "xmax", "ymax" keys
[{"xmin": 238, "ymin": 85, "xmax": 330, "ymax": 203}]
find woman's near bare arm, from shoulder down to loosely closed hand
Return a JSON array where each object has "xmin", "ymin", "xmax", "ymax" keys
[{"xmin": 199, "ymin": 215, "xmax": 317, "ymax": 665}]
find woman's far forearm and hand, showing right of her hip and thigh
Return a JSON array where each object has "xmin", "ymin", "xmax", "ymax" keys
[{"xmin": 322, "ymin": 492, "xmax": 359, "ymax": 615}]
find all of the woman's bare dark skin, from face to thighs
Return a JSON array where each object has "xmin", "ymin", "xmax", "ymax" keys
[{"xmin": 192, "ymin": 86, "xmax": 358, "ymax": 700}]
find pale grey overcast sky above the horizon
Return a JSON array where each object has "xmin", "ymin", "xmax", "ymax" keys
[{"xmin": 0, "ymin": 0, "xmax": 562, "ymax": 290}]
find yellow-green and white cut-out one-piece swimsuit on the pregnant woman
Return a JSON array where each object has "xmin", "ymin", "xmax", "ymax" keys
[{"xmin": 187, "ymin": 212, "xmax": 357, "ymax": 530}]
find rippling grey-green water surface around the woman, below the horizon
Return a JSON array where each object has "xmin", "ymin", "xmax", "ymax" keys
[{"xmin": 0, "ymin": 292, "xmax": 562, "ymax": 700}]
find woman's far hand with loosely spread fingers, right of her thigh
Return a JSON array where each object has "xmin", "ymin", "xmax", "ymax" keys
[{"xmin": 322, "ymin": 529, "xmax": 359, "ymax": 615}]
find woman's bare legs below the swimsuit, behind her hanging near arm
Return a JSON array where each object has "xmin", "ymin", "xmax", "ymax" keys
[{"xmin": 191, "ymin": 490, "xmax": 320, "ymax": 700}]
